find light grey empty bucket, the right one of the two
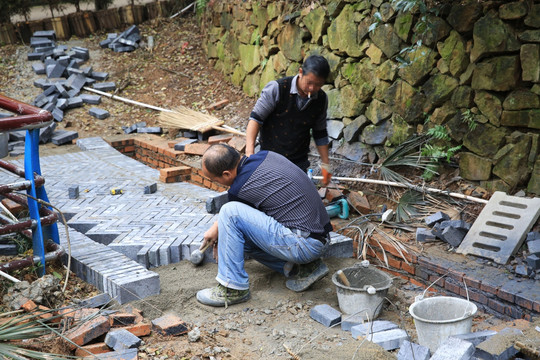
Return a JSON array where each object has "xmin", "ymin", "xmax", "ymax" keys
[{"xmin": 409, "ymin": 296, "xmax": 477, "ymax": 354}]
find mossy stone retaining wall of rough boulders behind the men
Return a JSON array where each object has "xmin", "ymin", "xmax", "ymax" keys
[{"xmin": 204, "ymin": 0, "xmax": 540, "ymax": 194}]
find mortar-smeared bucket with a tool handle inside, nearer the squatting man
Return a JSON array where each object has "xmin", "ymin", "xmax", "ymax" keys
[{"xmin": 332, "ymin": 266, "xmax": 392, "ymax": 321}]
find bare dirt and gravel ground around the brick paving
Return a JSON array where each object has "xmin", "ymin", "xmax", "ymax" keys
[{"xmin": 0, "ymin": 11, "xmax": 528, "ymax": 359}]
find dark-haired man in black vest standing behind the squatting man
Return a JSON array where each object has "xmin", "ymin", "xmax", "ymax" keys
[{"xmin": 246, "ymin": 55, "xmax": 332, "ymax": 185}]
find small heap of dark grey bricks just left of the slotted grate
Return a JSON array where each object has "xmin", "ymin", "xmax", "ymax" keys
[{"xmin": 416, "ymin": 211, "xmax": 471, "ymax": 248}]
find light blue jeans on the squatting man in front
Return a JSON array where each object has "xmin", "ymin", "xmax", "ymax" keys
[{"xmin": 216, "ymin": 201, "xmax": 326, "ymax": 290}]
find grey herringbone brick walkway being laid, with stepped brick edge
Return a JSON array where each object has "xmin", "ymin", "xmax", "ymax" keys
[{"xmin": 0, "ymin": 138, "xmax": 352, "ymax": 303}]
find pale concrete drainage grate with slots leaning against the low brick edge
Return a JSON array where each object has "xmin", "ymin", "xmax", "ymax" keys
[{"xmin": 458, "ymin": 191, "xmax": 540, "ymax": 264}]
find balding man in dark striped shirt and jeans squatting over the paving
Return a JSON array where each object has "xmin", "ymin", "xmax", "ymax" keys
[{"xmin": 197, "ymin": 144, "xmax": 332, "ymax": 306}]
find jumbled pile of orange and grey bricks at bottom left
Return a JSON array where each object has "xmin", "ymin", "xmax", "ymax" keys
[{"xmin": 13, "ymin": 293, "xmax": 189, "ymax": 360}]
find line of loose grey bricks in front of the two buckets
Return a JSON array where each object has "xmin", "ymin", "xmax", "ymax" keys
[{"xmin": 310, "ymin": 304, "xmax": 532, "ymax": 360}]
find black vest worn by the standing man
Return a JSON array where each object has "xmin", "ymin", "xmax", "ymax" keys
[{"xmin": 260, "ymin": 76, "xmax": 326, "ymax": 163}]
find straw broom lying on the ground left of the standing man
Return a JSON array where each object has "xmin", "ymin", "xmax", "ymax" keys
[{"xmin": 159, "ymin": 106, "xmax": 246, "ymax": 136}]
